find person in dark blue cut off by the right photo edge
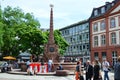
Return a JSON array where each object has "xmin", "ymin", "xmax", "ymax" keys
[{"xmin": 114, "ymin": 56, "xmax": 120, "ymax": 80}]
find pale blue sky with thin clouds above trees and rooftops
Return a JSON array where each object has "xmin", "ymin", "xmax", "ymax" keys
[{"xmin": 0, "ymin": 0, "xmax": 113, "ymax": 29}]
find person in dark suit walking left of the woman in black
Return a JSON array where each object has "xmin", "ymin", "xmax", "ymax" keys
[{"xmin": 86, "ymin": 60, "xmax": 93, "ymax": 80}]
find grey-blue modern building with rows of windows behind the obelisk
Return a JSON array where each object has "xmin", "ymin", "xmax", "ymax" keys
[{"xmin": 60, "ymin": 20, "xmax": 90, "ymax": 62}]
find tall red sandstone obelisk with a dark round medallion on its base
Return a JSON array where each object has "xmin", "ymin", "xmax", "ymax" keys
[{"xmin": 43, "ymin": 5, "xmax": 59, "ymax": 62}]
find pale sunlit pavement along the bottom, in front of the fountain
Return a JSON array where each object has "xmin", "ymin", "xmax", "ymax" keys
[{"xmin": 0, "ymin": 72, "xmax": 114, "ymax": 80}]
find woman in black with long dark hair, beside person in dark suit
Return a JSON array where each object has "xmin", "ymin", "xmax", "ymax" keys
[{"xmin": 93, "ymin": 60, "xmax": 101, "ymax": 80}]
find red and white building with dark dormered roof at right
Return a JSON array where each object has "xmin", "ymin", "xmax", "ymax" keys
[{"xmin": 90, "ymin": 0, "xmax": 120, "ymax": 66}]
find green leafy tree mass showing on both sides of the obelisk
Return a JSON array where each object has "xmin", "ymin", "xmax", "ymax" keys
[{"xmin": 0, "ymin": 6, "xmax": 68, "ymax": 56}]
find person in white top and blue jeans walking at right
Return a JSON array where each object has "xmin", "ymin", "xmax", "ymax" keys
[{"xmin": 102, "ymin": 59, "xmax": 110, "ymax": 80}]
